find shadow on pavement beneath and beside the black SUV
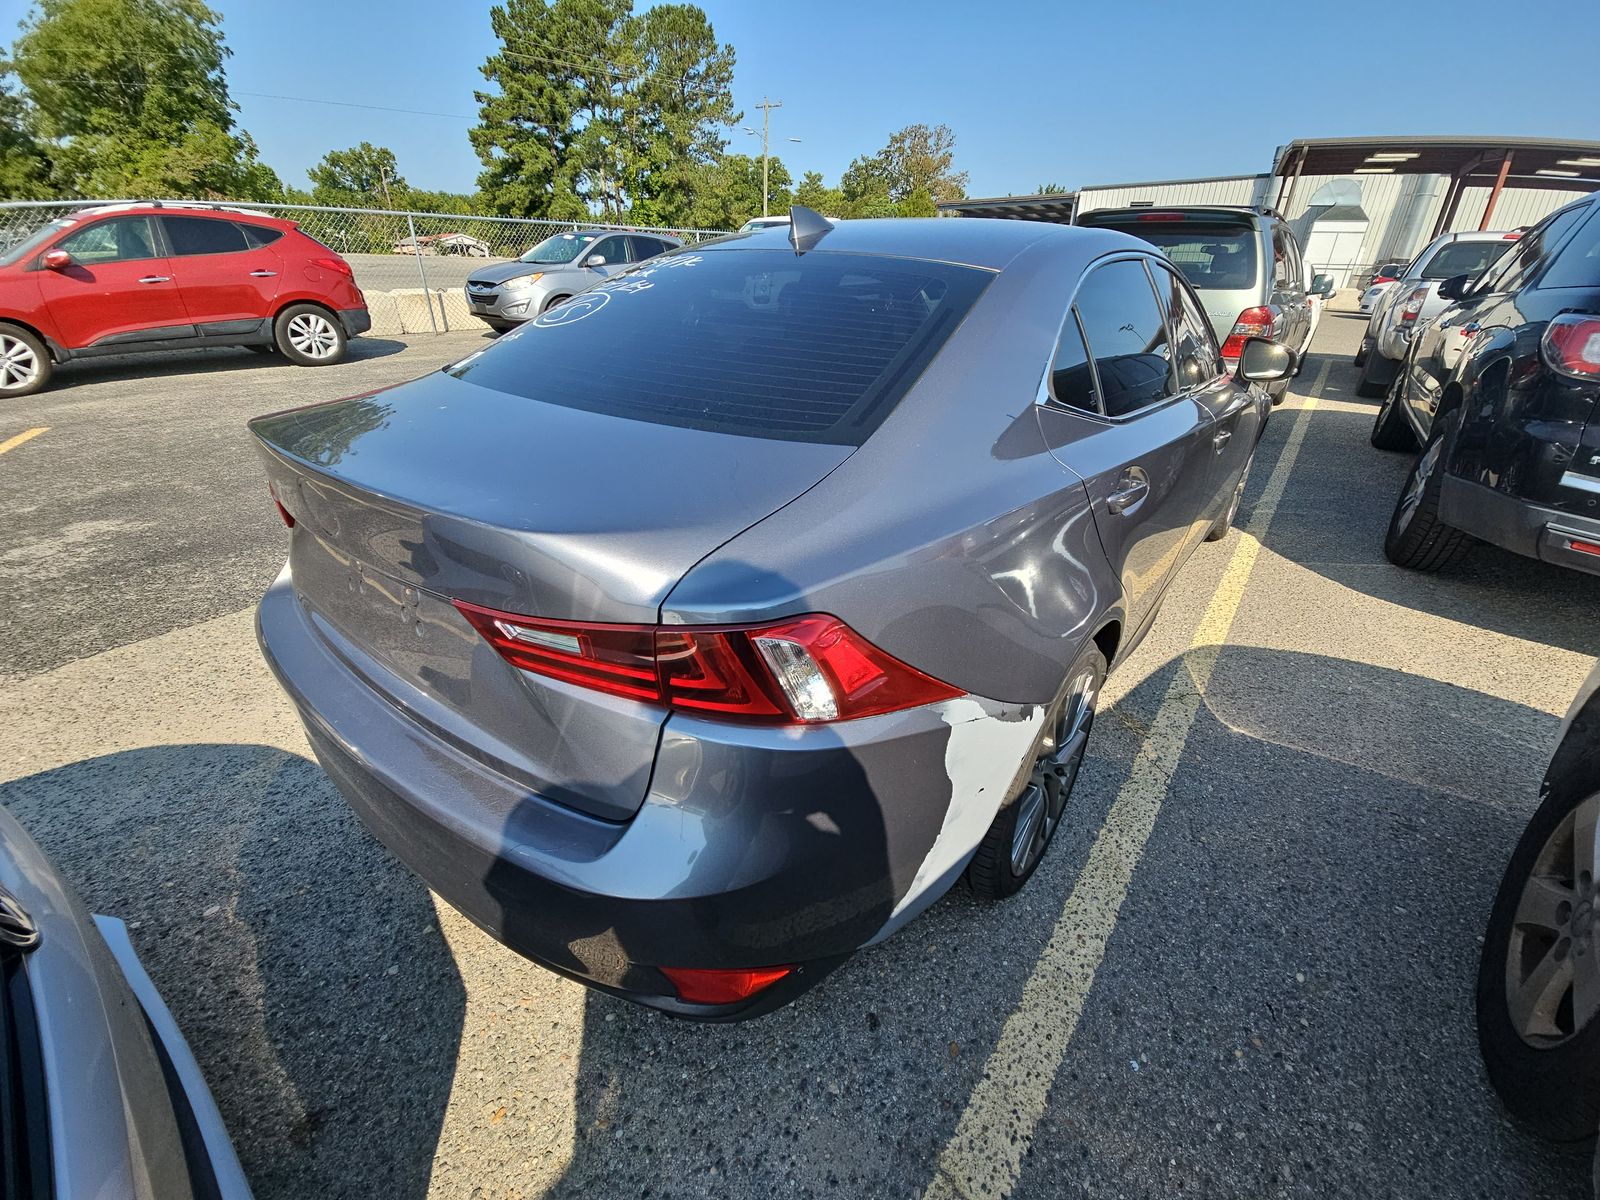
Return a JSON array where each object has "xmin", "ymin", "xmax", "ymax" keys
[{"xmin": 1240, "ymin": 404, "xmax": 1600, "ymax": 654}]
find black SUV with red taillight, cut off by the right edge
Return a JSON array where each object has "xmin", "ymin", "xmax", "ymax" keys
[{"xmin": 1373, "ymin": 195, "xmax": 1600, "ymax": 574}]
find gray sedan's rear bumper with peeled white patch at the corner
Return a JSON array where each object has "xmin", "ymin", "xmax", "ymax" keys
[{"xmin": 258, "ymin": 570, "xmax": 1029, "ymax": 1019}]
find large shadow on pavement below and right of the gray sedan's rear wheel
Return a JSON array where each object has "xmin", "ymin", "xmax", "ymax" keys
[{"xmin": 544, "ymin": 646, "xmax": 1582, "ymax": 1200}]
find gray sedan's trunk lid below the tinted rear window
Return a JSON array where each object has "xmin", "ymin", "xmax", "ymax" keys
[{"xmin": 251, "ymin": 373, "xmax": 851, "ymax": 819}]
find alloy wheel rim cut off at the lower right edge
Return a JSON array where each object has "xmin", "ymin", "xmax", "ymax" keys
[{"xmin": 1506, "ymin": 792, "xmax": 1600, "ymax": 1050}]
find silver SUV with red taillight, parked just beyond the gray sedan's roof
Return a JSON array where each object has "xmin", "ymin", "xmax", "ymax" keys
[{"xmin": 1075, "ymin": 205, "xmax": 1333, "ymax": 403}]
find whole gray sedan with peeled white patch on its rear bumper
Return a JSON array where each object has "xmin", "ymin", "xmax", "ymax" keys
[{"xmin": 251, "ymin": 208, "xmax": 1294, "ymax": 1019}]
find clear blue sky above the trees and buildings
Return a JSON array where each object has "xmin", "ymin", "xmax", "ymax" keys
[{"xmin": 0, "ymin": 0, "xmax": 1600, "ymax": 195}]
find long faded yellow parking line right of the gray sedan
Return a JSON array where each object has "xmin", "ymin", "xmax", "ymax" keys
[{"xmin": 923, "ymin": 369, "xmax": 1330, "ymax": 1200}]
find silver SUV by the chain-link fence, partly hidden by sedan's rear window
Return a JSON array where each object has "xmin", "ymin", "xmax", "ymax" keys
[{"xmin": 467, "ymin": 229, "xmax": 683, "ymax": 333}]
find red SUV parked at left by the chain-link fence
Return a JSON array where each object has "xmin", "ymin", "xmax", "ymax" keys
[{"xmin": 0, "ymin": 203, "xmax": 373, "ymax": 398}]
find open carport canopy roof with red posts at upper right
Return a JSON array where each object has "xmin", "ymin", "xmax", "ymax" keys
[{"xmin": 1272, "ymin": 136, "xmax": 1600, "ymax": 237}]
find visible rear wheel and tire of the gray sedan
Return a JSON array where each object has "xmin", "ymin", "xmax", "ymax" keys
[{"xmin": 966, "ymin": 643, "xmax": 1106, "ymax": 899}]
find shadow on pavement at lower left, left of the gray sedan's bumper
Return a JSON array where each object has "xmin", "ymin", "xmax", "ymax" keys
[{"xmin": 0, "ymin": 744, "xmax": 466, "ymax": 1200}]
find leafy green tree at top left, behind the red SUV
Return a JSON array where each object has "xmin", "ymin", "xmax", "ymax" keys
[{"xmin": 11, "ymin": 0, "xmax": 282, "ymax": 200}]
